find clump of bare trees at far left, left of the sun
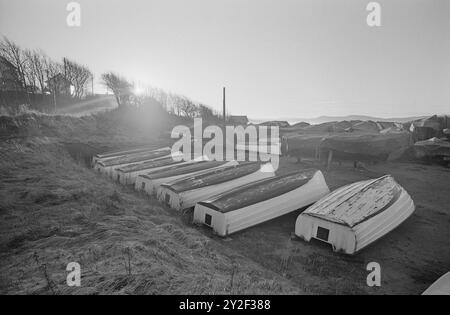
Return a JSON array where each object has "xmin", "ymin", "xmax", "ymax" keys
[{"xmin": 0, "ymin": 37, "xmax": 93, "ymax": 106}]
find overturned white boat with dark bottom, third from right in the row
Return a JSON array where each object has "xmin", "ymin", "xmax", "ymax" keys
[{"xmin": 158, "ymin": 162, "xmax": 275, "ymax": 210}]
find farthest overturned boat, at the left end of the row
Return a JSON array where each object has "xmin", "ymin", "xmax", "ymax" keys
[{"xmin": 94, "ymin": 148, "xmax": 171, "ymax": 178}]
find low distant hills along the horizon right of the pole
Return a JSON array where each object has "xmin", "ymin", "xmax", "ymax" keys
[{"xmin": 250, "ymin": 115, "xmax": 431, "ymax": 125}]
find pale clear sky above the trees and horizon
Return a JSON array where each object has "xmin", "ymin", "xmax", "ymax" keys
[{"xmin": 0, "ymin": 0, "xmax": 450, "ymax": 119}]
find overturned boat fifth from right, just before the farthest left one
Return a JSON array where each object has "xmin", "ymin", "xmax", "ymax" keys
[{"xmin": 115, "ymin": 153, "xmax": 185, "ymax": 185}]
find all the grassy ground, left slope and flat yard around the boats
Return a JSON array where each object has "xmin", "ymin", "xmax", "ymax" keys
[{"xmin": 0, "ymin": 114, "xmax": 450, "ymax": 294}]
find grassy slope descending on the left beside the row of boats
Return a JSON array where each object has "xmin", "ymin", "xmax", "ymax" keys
[{"xmin": 0, "ymin": 115, "xmax": 303, "ymax": 294}]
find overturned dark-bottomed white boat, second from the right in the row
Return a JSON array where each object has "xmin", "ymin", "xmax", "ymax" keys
[{"xmin": 194, "ymin": 169, "xmax": 330, "ymax": 236}]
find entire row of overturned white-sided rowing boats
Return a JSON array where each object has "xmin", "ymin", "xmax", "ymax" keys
[{"xmin": 93, "ymin": 147, "xmax": 415, "ymax": 254}]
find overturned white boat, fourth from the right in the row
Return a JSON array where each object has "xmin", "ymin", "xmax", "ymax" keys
[{"xmin": 135, "ymin": 161, "xmax": 238, "ymax": 195}]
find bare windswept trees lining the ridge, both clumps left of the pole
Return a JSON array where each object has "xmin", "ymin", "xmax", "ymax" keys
[{"xmin": 0, "ymin": 37, "xmax": 220, "ymax": 121}]
